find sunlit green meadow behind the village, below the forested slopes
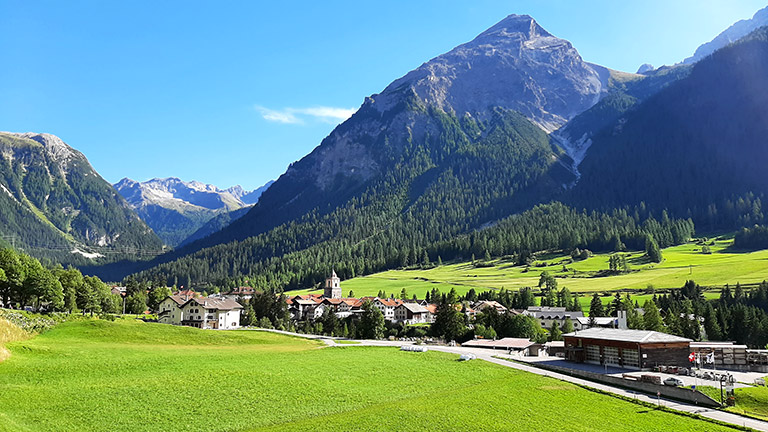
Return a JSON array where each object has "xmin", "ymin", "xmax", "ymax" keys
[{"xmin": 291, "ymin": 240, "xmax": 768, "ymax": 305}]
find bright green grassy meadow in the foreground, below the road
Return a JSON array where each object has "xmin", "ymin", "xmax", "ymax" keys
[{"xmin": 0, "ymin": 320, "xmax": 744, "ymax": 432}]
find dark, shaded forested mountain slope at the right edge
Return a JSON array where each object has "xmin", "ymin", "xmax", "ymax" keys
[{"xmin": 574, "ymin": 27, "xmax": 768, "ymax": 228}]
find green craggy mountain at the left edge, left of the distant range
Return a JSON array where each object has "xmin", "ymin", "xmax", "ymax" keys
[{"xmin": 0, "ymin": 132, "xmax": 162, "ymax": 264}]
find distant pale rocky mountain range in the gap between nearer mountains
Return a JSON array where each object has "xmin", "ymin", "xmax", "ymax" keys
[{"xmin": 114, "ymin": 177, "xmax": 273, "ymax": 246}]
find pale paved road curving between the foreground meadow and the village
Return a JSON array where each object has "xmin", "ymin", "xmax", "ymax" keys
[{"xmin": 256, "ymin": 330, "xmax": 768, "ymax": 432}]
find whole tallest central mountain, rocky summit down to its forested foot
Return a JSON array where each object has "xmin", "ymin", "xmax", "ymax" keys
[{"xmin": 114, "ymin": 15, "xmax": 632, "ymax": 280}]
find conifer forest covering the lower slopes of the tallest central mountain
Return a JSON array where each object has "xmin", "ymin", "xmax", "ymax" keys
[{"xmin": 132, "ymin": 104, "xmax": 572, "ymax": 286}]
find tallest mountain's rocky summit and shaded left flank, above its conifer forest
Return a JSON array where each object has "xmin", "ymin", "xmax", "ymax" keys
[{"xmin": 171, "ymin": 15, "xmax": 607, "ymax": 253}]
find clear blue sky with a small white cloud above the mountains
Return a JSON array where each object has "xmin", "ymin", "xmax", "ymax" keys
[{"xmin": 0, "ymin": 0, "xmax": 765, "ymax": 188}]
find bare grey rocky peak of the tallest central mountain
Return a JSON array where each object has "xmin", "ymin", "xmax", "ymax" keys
[{"xmin": 366, "ymin": 15, "xmax": 606, "ymax": 132}]
